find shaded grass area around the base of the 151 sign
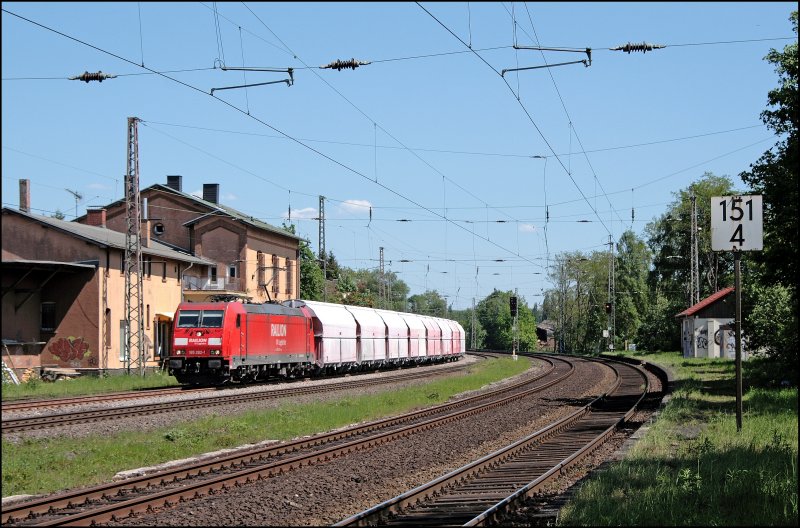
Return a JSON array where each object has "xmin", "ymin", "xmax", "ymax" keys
[{"xmin": 559, "ymin": 352, "xmax": 798, "ymax": 526}]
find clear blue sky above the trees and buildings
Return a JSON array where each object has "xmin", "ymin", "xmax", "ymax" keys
[{"xmin": 2, "ymin": 2, "xmax": 796, "ymax": 309}]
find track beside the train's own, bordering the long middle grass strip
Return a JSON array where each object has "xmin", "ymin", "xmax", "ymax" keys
[{"xmin": 0, "ymin": 364, "xmax": 466, "ymax": 434}]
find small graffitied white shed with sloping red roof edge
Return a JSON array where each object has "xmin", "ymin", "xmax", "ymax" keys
[{"xmin": 675, "ymin": 286, "xmax": 748, "ymax": 359}]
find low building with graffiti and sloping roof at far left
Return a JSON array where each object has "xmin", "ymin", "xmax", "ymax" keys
[{"xmin": 0, "ymin": 205, "xmax": 215, "ymax": 374}]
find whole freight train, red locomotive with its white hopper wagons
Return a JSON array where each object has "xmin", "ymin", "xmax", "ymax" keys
[{"xmin": 168, "ymin": 300, "xmax": 465, "ymax": 385}]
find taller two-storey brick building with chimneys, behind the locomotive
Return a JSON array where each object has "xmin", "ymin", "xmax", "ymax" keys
[{"xmin": 76, "ymin": 176, "xmax": 302, "ymax": 302}]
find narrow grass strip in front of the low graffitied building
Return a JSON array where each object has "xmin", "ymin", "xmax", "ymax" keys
[{"xmin": 3, "ymin": 372, "xmax": 179, "ymax": 402}]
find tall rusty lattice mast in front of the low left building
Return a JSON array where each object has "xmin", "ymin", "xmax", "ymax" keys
[{"xmin": 124, "ymin": 117, "xmax": 145, "ymax": 376}]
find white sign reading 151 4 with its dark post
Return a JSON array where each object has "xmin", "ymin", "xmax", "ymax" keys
[{"xmin": 711, "ymin": 194, "xmax": 764, "ymax": 431}]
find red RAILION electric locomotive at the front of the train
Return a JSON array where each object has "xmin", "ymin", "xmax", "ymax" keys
[{"xmin": 169, "ymin": 302, "xmax": 315, "ymax": 385}]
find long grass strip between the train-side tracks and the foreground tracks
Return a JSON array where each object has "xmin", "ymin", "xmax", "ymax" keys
[{"xmin": 2, "ymin": 358, "xmax": 530, "ymax": 496}]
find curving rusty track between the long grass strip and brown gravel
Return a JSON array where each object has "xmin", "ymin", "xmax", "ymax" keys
[{"xmin": 2, "ymin": 352, "xmax": 575, "ymax": 526}]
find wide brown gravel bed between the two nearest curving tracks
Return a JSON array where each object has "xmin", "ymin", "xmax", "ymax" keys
[{"xmin": 104, "ymin": 356, "xmax": 612, "ymax": 526}]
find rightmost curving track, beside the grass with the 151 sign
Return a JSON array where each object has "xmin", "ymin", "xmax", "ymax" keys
[{"xmin": 334, "ymin": 356, "xmax": 648, "ymax": 526}]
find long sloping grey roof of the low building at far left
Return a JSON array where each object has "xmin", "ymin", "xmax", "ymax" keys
[{"xmin": 3, "ymin": 207, "xmax": 216, "ymax": 266}]
